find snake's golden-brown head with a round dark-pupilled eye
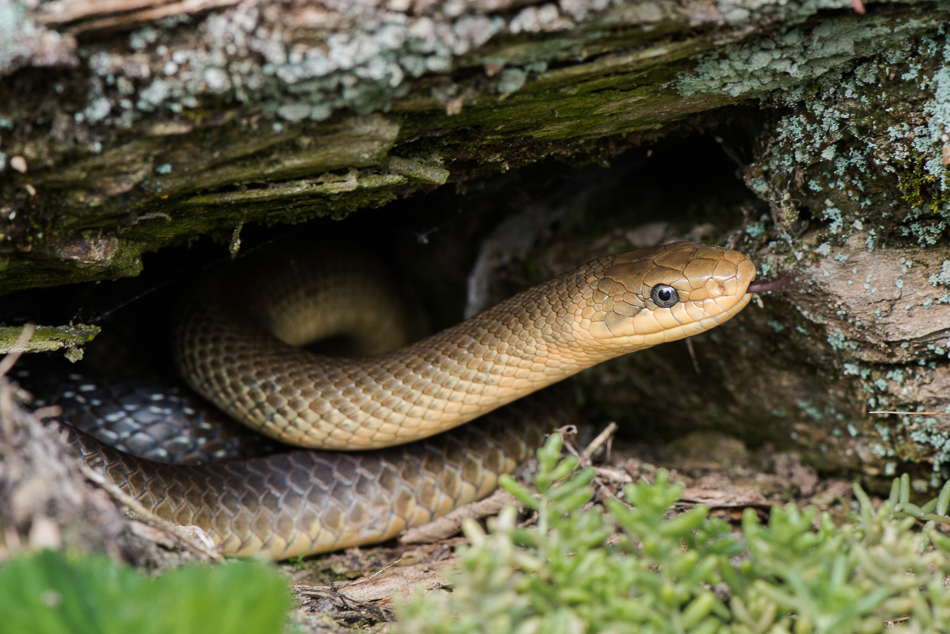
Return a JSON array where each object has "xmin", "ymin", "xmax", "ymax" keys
[{"xmin": 584, "ymin": 242, "xmax": 755, "ymax": 351}]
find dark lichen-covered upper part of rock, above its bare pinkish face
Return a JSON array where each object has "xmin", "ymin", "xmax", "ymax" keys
[{"xmin": 746, "ymin": 25, "xmax": 950, "ymax": 251}]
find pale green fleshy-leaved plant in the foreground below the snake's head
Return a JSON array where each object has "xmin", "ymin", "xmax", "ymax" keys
[{"xmin": 395, "ymin": 436, "xmax": 950, "ymax": 634}]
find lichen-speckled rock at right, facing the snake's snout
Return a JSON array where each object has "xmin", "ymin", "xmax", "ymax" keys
[{"xmin": 745, "ymin": 24, "xmax": 950, "ymax": 484}]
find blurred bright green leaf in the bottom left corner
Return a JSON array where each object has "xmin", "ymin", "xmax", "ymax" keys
[{"xmin": 0, "ymin": 551, "xmax": 292, "ymax": 634}]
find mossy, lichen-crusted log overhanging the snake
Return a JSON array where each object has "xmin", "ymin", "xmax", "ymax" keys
[{"xmin": 0, "ymin": 0, "xmax": 945, "ymax": 292}]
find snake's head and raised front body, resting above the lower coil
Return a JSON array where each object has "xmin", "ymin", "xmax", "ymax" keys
[{"xmin": 176, "ymin": 243, "xmax": 755, "ymax": 451}]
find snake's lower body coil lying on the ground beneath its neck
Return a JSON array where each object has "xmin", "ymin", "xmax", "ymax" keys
[{"xmin": 66, "ymin": 395, "xmax": 569, "ymax": 559}]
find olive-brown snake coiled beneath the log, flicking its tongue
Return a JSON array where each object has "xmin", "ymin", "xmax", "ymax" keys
[{"xmin": 33, "ymin": 242, "xmax": 777, "ymax": 560}]
